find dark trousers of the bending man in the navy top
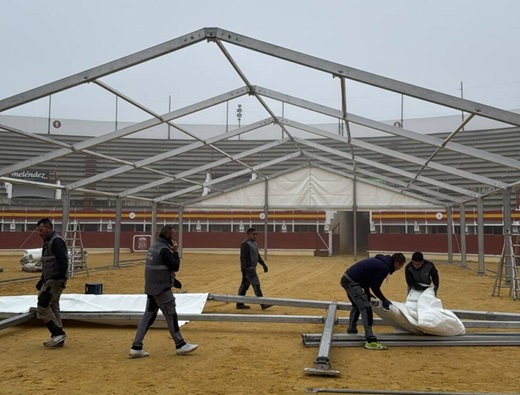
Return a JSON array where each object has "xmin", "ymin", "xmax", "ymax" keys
[{"xmin": 340, "ymin": 276, "xmax": 377, "ymax": 342}]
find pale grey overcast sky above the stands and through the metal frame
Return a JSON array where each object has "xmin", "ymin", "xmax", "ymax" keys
[{"xmin": 0, "ymin": 0, "xmax": 520, "ymax": 124}]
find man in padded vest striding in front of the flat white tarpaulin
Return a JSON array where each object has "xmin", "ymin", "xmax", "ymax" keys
[{"xmin": 129, "ymin": 226, "xmax": 198, "ymax": 358}]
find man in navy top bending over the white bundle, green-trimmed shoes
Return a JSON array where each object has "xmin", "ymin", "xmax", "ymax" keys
[{"xmin": 340, "ymin": 252, "xmax": 406, "ymax": 350}]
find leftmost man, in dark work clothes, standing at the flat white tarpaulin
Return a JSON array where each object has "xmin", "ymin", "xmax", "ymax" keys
[{"xmin": 36, "ymin": 218, "xmax": 69, "ymax": 348}]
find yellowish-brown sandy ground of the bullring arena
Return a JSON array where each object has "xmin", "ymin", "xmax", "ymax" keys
[{"xmin": 0, "ymin": 254, "xmax": 520, "ymax": 395}]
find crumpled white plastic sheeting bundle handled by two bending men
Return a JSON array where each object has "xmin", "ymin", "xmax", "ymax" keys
[{"xmin": 374, "ymin": 288, "xmax": 466, "ymax": 336}]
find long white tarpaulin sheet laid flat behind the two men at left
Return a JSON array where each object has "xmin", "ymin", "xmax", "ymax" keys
[{"xmin": 0, "ymin": 293, "xmax": 208, "ymax": 325}]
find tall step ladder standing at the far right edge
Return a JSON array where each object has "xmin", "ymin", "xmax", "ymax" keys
[{"xmin": 491, "ymin": 231, "xmax": 520, "ymax": 300}]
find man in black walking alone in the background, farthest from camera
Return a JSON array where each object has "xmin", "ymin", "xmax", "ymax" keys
[{"xmin": 236, "ymin": 228, "xmax": 271, "ymax": 310}]
